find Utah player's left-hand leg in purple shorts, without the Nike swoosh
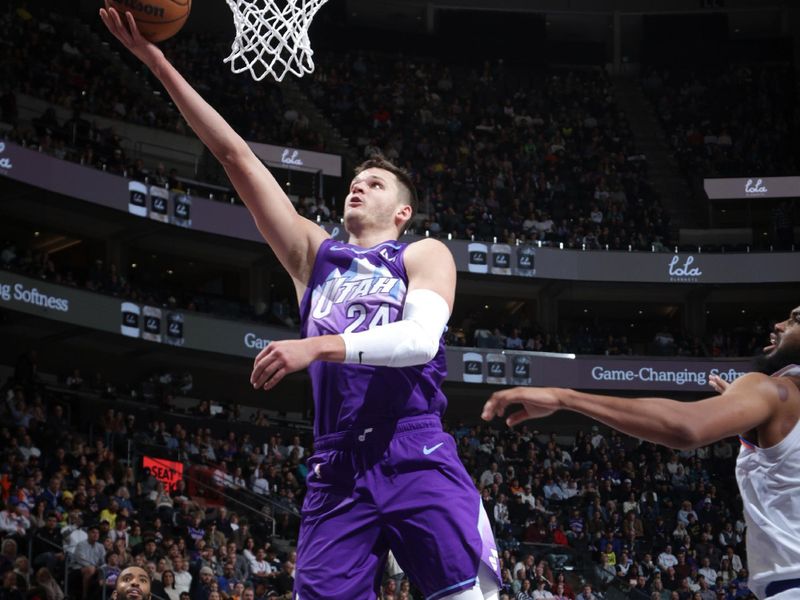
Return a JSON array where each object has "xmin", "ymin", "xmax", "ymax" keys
[{"xmin": 294, "ymin": 451, "xmax": 388, "ymax": 600}]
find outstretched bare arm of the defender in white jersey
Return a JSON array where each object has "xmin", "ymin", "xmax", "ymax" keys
[{"xmin": 481, "ymin": 373, "xmax": 798, "ymax": 449}]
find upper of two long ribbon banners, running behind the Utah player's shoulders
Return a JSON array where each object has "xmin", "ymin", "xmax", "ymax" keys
[{"xmin": 0, "ymin": 142, "xmax": 800, "ymax": 285}]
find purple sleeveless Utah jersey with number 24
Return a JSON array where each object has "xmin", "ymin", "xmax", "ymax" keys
[{"xmin": 300, "ymin": 239, "xmax": 447, "ymax": 436}]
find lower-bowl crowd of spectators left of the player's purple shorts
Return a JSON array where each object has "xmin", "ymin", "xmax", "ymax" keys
[{"xmin": 0, "ymin": 354, "xmax": 304, "ymax": 600}]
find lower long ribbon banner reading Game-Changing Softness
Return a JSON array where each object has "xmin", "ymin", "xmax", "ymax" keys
[{"xmin": 0, "ymin": 271, "xmax": 750, "ymax": 393}]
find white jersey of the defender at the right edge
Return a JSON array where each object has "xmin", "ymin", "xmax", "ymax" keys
[{"xmin": 736, "ymin": 365, "xmax": 800, "ymax": 599}]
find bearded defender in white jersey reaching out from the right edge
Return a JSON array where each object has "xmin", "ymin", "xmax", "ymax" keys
[{"xmin": 482, "ymin": 306, "xmax": 800, "ymax": 600}]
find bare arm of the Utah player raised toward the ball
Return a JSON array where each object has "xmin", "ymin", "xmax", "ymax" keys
[{"xmin": 100, "ymin": 6, "xmax": 327, "ymax": 290}]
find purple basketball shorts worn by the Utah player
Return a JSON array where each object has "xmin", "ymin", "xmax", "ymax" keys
[{"xmin": 295, "ymin": 415, "xmax": 499, "ymax": 600}]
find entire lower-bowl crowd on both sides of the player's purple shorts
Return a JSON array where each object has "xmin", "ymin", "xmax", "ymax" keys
[{"xmin": 0, "ymin": 346, "xmax": 752, "ymax": 600}]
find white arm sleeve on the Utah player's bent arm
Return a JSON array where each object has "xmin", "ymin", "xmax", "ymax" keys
[{"xmin": 341, "ymin": 290, "xmax": 450, "ymax": 367}]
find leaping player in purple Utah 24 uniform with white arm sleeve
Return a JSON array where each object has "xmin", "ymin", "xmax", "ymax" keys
[{"xmin": 100, "ymin": 7, "xmax": 499, "ymax": 600}]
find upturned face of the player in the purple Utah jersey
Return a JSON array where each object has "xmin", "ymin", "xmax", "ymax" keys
[{"xmin": 344, "ymin": 168, "xmax": 407, "ymax": 234}]
